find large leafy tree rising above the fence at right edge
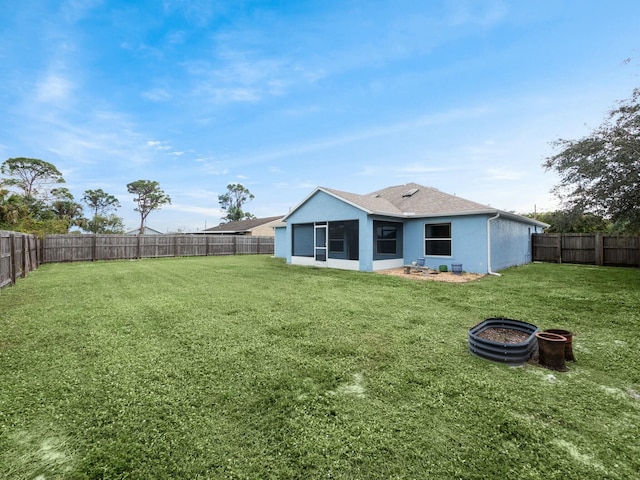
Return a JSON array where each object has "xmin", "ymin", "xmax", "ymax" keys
[{"xmin": 544, "ymin": 88, "xmax": 640, "ymax": 233}]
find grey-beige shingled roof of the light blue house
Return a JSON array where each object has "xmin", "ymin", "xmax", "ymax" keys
[{"xmin": 285, "ymin": 183, "xmax": 548, "ymax": 227}]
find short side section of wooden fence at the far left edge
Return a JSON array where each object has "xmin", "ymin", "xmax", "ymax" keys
[{"xmin": 0, "ymin": 230, "xmax": 40, "ymax": 288}]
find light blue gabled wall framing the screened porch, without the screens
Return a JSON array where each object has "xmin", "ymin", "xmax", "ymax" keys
[{"xmin": 284, "ymin": 191, "xmax": 372, "ymax": 270}]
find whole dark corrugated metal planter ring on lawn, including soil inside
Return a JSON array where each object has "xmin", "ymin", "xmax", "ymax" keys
[{"xmin": 469, "ymin": 318, "xmax": 538, "ymax": 365}]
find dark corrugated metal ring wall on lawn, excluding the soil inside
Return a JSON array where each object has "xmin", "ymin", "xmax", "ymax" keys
[{"xmin": 469, "ymin": 318, "xmax": 538, "ymax": 365}]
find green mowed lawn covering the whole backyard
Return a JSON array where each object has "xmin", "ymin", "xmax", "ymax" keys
[{"xmin": 0, "ymin": 256, "xmax": 640, "ymax": 480}]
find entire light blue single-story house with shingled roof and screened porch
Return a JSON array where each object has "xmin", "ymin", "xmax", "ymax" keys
[{"xmin": 275, "ymin": 183, "xmax": 548, "ymax": 273}]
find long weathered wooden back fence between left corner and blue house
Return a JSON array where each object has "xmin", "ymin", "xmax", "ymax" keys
[{"xmin": 41, "ymin": 235, "xmax": 274, "ymax": 263}]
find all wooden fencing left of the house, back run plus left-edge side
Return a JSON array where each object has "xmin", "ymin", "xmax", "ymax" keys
[{"xmin": 0, "ymin": 231, "xmax": 274, "ymax": 288}]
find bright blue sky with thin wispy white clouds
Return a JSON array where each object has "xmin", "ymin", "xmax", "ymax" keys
[{"xmin": 0, "ymin": 0, "xmax": 640, "ymax": 232}]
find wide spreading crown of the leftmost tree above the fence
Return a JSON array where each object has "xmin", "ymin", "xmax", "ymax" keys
[{"xmin": 0, "ymin": 157, "xmax": 65, "ymax": 198}]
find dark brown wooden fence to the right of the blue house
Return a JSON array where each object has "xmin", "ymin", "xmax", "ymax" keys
[{"xmin": 531, "ymin": 233, "xmax": 640, "ymax": 267}]
